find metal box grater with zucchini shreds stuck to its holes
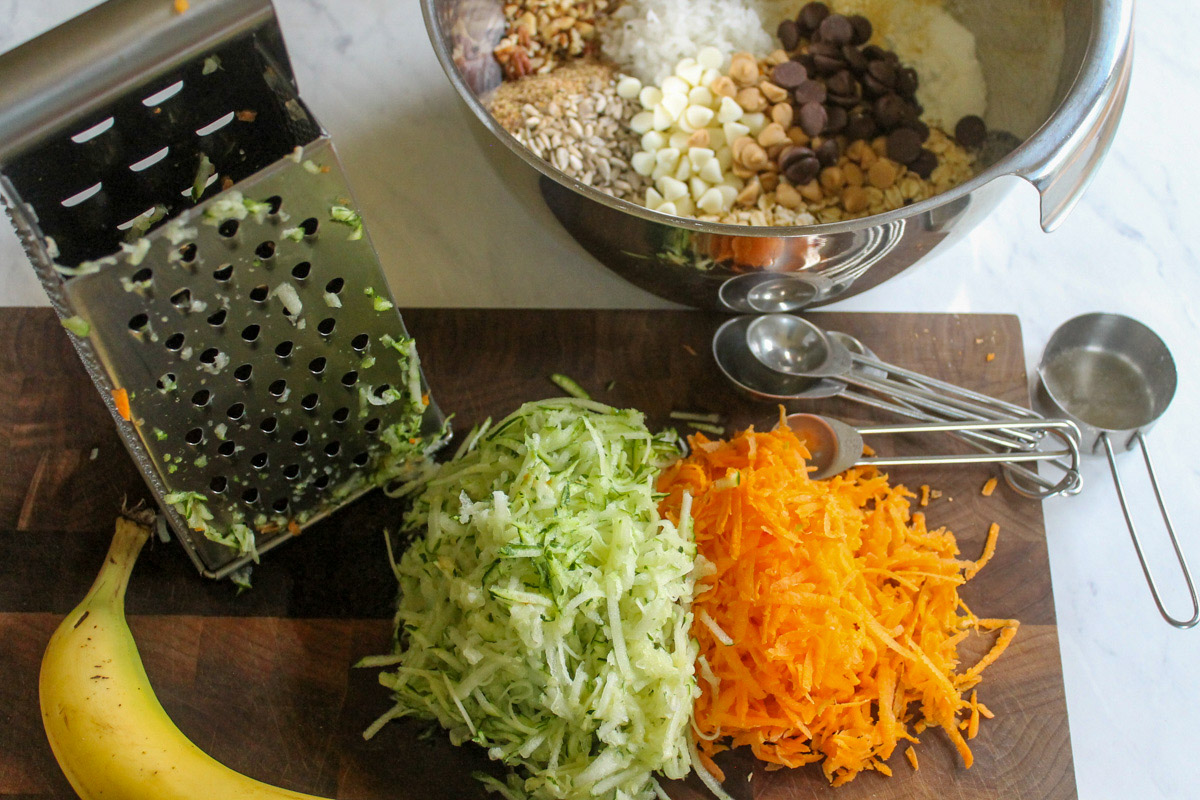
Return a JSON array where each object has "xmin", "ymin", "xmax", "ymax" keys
[{"xmin": 0, "ymin": 0, "xmax": 449, "ymax": 578}]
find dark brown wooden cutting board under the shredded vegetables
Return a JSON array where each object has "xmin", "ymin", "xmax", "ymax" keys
[{"xmin": 0, "ymin": 308, "xmax": 1076, "ymax": 800}]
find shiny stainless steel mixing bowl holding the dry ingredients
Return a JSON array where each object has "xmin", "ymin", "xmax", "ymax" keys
[{"xmin": 421, "ymin": 0, "xmax": 1133, "ymax": 313}]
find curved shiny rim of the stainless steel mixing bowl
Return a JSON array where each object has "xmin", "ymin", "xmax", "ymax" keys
[{"xmin": 420, "ymin": 0, "xmax": 1134, "ymax": 239}]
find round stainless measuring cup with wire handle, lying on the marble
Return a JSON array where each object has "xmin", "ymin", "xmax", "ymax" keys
[{"xmin": 1037, "ymin": 313, "xmax": 1200, "ymax": 628}]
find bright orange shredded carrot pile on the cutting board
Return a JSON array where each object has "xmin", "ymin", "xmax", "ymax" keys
[{"xmin": 659, "ymin": 426, "xmax": 1018, "ymax": 786}]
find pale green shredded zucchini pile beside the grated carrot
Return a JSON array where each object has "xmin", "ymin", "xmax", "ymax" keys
[{"xmin": 367, "ymin": 398, "xmax": 697, "ymax": 799}]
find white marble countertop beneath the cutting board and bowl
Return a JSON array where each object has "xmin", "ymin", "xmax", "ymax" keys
[{"xmin": 0, "ymin": 0, "xmax": 1200, "ymax": 800}]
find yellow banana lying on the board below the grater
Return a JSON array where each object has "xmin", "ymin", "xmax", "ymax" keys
[{"xmin": 38, "ymin": 517, "xmax": 331, "ymax": 800}]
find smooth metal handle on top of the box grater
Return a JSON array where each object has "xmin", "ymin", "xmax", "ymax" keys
[{"xmin": 0, "ymin": 0, "xmax": 285, "ymax": 166}]
